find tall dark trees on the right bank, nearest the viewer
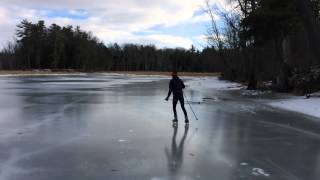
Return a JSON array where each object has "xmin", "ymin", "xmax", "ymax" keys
[{"xmin": 206, "ymin": 0, "xmax": 320, "ymax": 91}]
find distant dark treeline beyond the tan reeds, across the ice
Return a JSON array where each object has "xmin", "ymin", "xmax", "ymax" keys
[{"xmin": 0, "ymin": 20, "xmax": 221, "ymax": 72}]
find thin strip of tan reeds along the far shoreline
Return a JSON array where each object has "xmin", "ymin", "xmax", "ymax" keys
[{"xmin": 0, "ymin": 69, "xmax": 220, "ymax": 77}]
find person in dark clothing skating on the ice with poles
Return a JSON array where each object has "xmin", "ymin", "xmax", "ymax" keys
[{"xmin": 165, "ymin": 71, "xmax": 189, "ymax": 123}]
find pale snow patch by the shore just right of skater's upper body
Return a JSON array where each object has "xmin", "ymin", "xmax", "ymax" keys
[{"xmin": 185, "ymin": 77, "xmax": 243, "ymax": 90}]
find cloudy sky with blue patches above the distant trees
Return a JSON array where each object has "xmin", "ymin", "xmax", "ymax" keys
[{"xmin": 0, "ymin": 0, "xmax": 230, "ymax": 50}]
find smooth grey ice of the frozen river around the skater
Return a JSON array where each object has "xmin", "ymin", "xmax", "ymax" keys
[{"xmin": 0, "ymin": 74, "xmax": 320, "ymax": 180}]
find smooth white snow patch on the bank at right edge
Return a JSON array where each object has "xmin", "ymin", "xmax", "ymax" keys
[{"xmin": 269, "ymin": 97, "xmax": 320, "ymax": 118}]
